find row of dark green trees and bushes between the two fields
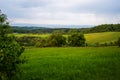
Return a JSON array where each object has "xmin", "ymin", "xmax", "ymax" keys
[{"xmin": 15, "ymin": 33, "xmax": 86, "ymax": 47}]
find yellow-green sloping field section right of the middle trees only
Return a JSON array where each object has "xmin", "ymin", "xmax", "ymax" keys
[{"xmin": 85, "ymin": 32, "xmax": 120, "ymax": 44}]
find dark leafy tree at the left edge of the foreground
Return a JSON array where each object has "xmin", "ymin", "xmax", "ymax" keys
[{"xmin": 0, "ymin": 11, "xmax": 24, "ymax": 80}]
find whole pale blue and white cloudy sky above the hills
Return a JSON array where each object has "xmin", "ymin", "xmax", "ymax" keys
[{"xmin": 0, "ymin": 0, "xmax": 120, "ymax": 25}]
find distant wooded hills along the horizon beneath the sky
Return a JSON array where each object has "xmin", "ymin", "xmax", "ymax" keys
[{"xmin": 12, "ymin": 24, "xmax": 120, "ymax": 34}]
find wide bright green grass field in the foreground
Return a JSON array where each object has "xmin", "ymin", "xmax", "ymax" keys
[{"xmin": 20, "ymin": 47, "xmax": 120, "ymax": 80}]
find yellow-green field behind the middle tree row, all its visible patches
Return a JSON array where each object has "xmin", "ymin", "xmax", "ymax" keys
[{"xmin": 15, "ymin": 32, "xmax": 120, "ymax": 44}]
